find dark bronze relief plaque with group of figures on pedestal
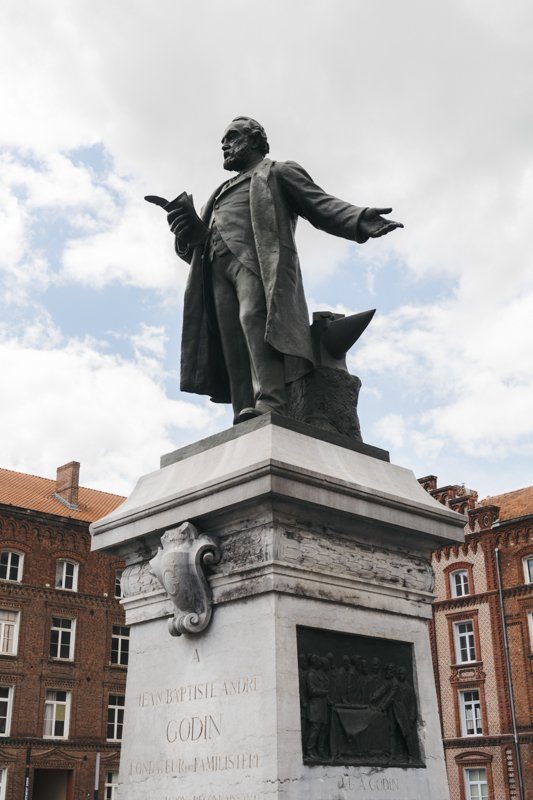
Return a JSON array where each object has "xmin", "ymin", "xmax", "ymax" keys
[{"xmin": 297, "ymin": 627, "xmax": 425, "ymax": 767}]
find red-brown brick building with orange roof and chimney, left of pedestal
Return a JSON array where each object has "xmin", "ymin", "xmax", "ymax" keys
[{"xmin": 0, "ymin": 462, "xmax": 128, "ymax": 800}]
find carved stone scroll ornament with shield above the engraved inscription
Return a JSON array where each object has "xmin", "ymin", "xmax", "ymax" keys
[{"xmin": 150, "ymin": 522, "xmax": 220, "ymax": 636}]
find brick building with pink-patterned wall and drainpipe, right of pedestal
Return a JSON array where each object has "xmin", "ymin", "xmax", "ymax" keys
[{"xmin": 420, "ymin": 475, "xmax": 533, "ymax": 800}]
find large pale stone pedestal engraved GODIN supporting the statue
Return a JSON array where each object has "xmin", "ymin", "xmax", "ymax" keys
[{"xmin": 92, "ymin": 416, "xmax": 464, "ymax": 800}]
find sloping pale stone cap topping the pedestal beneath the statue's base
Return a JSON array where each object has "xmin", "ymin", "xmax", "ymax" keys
[{"xmin": 92, "ymin": 420, "xmax": 463, "ymax": 555}]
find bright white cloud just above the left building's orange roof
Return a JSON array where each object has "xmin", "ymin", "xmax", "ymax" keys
[{"xmin": 0, "ymin": 326, "xmax": 222, "ymax": 494}]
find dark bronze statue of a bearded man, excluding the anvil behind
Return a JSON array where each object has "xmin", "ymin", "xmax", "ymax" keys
[{"xmin": 162, "ymin": 117, "xmax": 402, "ymax": 423}]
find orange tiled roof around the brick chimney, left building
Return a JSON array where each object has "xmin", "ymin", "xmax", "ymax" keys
[{"xmin": 0, "ymin": 468, "xmax": 125, "ymax": 522}]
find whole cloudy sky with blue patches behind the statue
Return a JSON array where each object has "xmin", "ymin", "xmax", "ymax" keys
[{"xmin": 0, "ymin": 0, "xmax": 533, "ymax": 497}]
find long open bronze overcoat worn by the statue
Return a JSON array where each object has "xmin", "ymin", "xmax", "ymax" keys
[{"xmin": 178, "ymin": 158, "xmax": 364, "ymax": 403}]
